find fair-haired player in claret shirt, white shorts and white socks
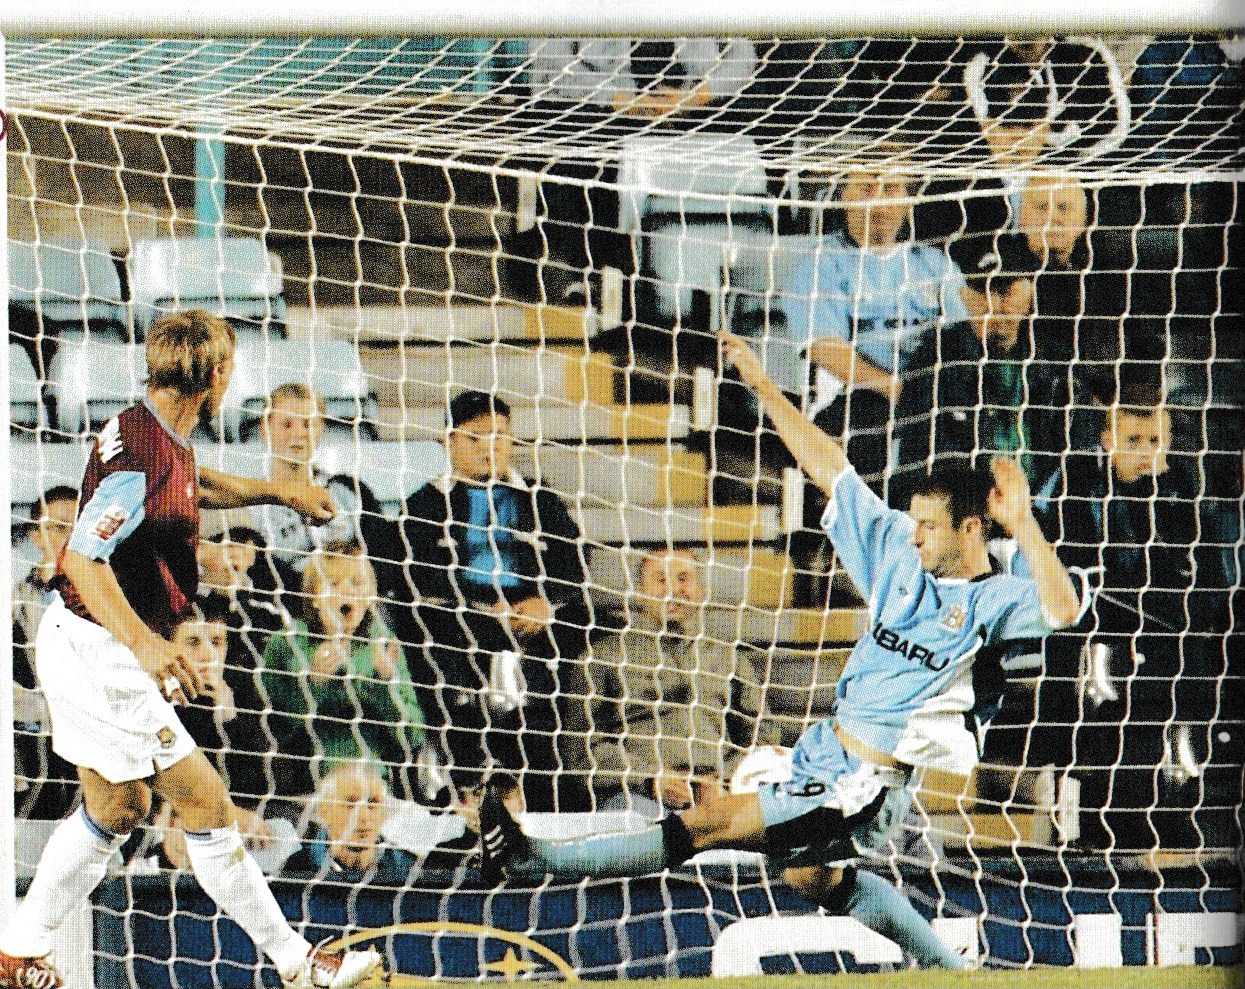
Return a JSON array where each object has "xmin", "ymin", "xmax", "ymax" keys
[{"xmin": 0, "ymin": 310, "xmax": 381, "ymax": 989}]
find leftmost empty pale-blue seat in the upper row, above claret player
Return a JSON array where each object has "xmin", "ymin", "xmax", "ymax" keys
[{"xmin": 9, "ymin": 240, "xmax": 128, "ymax": 339}]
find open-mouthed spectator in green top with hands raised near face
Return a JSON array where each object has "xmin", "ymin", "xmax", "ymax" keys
[{"xmin": 260, "ymin": 543, "xmax": 423, "ymax": 796}]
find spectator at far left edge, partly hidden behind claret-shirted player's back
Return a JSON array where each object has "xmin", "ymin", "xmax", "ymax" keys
[{"xmin": 12, "ymin": 485, "xmax": 78, "ymax": 821}]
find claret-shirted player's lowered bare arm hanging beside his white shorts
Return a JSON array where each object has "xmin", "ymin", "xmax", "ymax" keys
[{"xmin": 61, "ymin": 549, "xmax": 203, "ymax": 701}]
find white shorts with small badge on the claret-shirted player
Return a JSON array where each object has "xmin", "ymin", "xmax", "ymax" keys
[{"xmin": 35, "ymin": 597, "xmax": 195, "ymax": 783}]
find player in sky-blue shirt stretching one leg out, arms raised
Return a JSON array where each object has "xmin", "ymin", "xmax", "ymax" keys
[{"xmin": 481, "ymin": 334, "xmax": 1087, "ymax": 968}]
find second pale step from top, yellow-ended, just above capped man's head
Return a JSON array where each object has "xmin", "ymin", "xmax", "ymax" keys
[{"xmin": 361, "ymin": 344, "xmax": 614, "ymax": 405}]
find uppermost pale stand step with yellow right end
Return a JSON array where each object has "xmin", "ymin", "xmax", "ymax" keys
[{"xmin": 286, "ymin": 303, "xmax": 596, "ymax": 343}]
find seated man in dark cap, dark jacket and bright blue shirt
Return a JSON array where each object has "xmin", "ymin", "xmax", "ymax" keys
[{"xmin": 382, "ymin": 391, "xmax": 589, "ymax": 810}]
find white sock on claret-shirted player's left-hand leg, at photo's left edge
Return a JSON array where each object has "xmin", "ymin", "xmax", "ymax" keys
[{"xmin": 0, "ymin": 806, "xmax": 125, "ymax": 958}]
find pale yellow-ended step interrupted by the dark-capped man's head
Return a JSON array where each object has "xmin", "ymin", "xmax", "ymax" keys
[{"xmin": 377, "ymin": 395, "xmax": 691, "ymax": 443}]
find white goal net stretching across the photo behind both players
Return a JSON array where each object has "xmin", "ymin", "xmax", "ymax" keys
[{"xmin": 5, "ymin": 35, "xmax": 1245, "ymax": 987}]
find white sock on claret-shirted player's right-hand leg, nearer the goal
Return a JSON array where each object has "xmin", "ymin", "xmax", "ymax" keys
[{"xmin": 186, "ymin": 827, "xmax": 311, "ymax": 978}]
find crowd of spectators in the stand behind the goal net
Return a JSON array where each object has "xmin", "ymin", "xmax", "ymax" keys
[{"xmin": 11, "ymin": 32, "xmax": 1243, "ymax": 871}]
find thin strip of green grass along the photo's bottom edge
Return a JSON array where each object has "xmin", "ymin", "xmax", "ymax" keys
[{"xmin": 500, "ymin": 965, "xmax": 1245, "ymax": 989}]
